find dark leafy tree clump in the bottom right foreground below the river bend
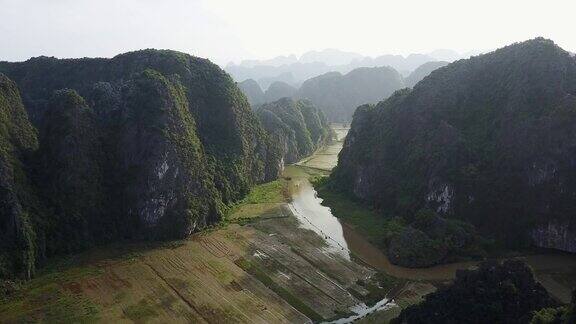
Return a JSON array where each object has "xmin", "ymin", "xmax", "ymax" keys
[{"xmin": 393, "ymin": 261, "xmax": 554, "ymax": 324}]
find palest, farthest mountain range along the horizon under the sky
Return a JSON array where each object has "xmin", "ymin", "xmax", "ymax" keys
[{"xmin": 225, "ymin": 49, "xmax": 479, "ymax": 90}]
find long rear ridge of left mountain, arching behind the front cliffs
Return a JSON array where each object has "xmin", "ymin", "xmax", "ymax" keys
[{"xmin": 0, "ymin": 50, "xmax": 276, "ymax": 201}]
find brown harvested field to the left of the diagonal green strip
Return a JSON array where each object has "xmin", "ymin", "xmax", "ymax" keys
[{"xmin": 0, "ymin": 225, "xmax": 309, "ymax": 323}]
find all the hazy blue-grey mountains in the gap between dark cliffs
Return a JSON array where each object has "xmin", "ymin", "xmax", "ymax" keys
[{"xmin": 226, "ymin": 49, "xmax": 470, "ymax": 122}]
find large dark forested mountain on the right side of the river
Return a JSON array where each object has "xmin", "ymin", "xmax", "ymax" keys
[{"xmin": 332, "ymin": 38, "xmax": 576, "ymax": 252}]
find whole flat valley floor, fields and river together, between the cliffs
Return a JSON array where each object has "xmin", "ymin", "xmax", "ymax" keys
[{"xmin": 0, "ymin": 119, "xmax": 576, "ymax": 323}]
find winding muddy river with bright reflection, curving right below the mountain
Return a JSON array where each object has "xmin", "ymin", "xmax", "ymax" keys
[{"xmin": 285, "ymin": 125, "xmax": 576, "ymax": 303}]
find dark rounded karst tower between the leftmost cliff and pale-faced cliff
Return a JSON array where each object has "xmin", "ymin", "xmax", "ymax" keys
[{"xmin": 34, "ymin": 90, "xmax": 106, "ymax": 253}]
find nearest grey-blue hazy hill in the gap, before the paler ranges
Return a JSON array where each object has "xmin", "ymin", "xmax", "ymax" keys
[{"xmin": 298, "ymin": 67, "xmax": 404, "ymax": 122}]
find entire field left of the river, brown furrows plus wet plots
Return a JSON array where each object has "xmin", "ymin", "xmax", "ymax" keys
[{"xmin": 0, "ymin": 181, "xmax": 392, "ymax": 323}]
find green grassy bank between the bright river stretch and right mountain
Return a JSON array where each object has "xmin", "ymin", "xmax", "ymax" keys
[{"xmin": 311, "ymin": 177, "xmax": 405, "ymax": 247}]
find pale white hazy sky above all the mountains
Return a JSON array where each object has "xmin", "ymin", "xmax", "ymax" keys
[{"xmin": 0, "ymin": 0, "xmax": 576, "ymax": 64}]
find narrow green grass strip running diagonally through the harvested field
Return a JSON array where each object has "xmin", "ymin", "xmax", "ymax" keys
[{"xmin": 234, "ymin": 258, "xmax": 323, "ymax": 322}]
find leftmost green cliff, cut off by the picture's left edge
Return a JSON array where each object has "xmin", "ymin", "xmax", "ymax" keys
[{"xmin": 0, "ymin": 74, "xmax": 38, "ymax": 278}]
